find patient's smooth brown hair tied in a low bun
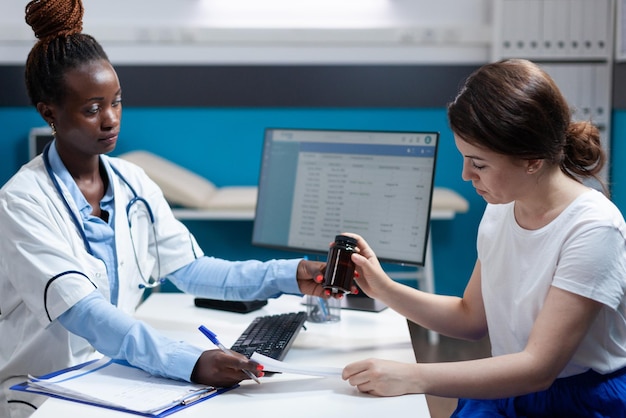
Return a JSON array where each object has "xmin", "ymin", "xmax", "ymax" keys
[{"xmin": 448, "ymin": 59, "xmax": 606, "ymax": 189}]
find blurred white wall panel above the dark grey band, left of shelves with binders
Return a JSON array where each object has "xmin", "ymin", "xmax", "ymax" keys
[{"xmin": 0, "ymin": 0, "xmax": 492, "ymax": 64}]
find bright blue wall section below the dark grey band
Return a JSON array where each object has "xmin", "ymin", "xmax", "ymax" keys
[{"xmin": 6, "ymin": 107, "xmax": 626, "ymax": 295}]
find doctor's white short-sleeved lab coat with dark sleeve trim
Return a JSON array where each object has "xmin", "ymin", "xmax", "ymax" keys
[{"xmin": 0, "ymin": 152, "xmax": 203, "ymax": 417}]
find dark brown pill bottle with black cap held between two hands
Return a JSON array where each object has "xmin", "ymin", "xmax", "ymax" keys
[{"xmin": 324, "ymin": 235, "xmax": 356, "ymax": 294}]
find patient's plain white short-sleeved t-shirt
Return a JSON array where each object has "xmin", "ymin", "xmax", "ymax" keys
[{"xmin": 477, "ymin": 190, "xmax": 626, "ymax": 377}]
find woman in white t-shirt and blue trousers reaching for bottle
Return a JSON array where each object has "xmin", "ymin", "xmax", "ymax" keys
[{"xmin": 343, "ymin": 60, "xmax": 626, "ymax": 418}]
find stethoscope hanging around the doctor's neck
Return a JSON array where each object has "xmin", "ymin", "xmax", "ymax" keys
[{"xmin": 42, "ymin": 142, "xmax": 165, "ymax": 289}]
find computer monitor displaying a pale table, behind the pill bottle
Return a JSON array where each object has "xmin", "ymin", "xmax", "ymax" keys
[{"xmin": 252, "ymin": 128, "xmax": 439, "ymax": 265}]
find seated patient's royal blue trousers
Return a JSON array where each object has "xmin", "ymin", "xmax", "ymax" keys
[{"xmin": 451, "ymin": 368, "xmax": 626, "ymax": 418}]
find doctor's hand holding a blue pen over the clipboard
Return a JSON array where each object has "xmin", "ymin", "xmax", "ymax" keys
[{"xmin": 191, "ymin": 350, "xmax": 263, "ymax": 387}]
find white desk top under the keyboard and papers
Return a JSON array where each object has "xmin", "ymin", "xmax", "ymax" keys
[{"xmin": 33, "ymin": 293, "xmax": 430, "ymax": 418}]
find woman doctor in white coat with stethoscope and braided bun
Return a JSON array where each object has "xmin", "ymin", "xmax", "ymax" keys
[{"xmin": 0, "ymin": 0, "xmax": 324, "ymax": 417}]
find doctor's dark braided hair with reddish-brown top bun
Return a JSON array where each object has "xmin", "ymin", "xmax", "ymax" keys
[{"xmin": 24, "ymin": 0, "xmax": 109, "ymax": 106}]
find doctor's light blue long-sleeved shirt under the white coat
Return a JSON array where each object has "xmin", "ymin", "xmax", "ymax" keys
[{"xmin": 49, "ymin": 144, "xmax": 300, "ymax": 381}]
